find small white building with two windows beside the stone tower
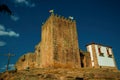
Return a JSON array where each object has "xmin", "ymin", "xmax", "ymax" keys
[{"xmin": 87, "ymin": 43, "xmax": 117, "ymax": 68}]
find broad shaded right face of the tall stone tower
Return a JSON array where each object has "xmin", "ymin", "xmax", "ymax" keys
[{"xmin": 53, "ymin": 16, "xmax": 80, "ymax": 67}]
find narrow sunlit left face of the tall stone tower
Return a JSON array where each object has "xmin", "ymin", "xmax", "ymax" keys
[{"xmin": 37, "ymin": 16, "xmax": 54, "ymax": 68}]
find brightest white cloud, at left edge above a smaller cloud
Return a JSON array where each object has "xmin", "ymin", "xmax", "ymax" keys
[{"xmin": 0, "ymin": 24, "xmax": 20, "ymax": 37}]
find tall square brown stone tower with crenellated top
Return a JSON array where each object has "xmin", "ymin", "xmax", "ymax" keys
[{"xmin": 36, "ymin": 13, "xmax": 81, "ymax": 68}]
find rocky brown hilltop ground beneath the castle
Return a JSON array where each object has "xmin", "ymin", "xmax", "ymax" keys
[{"xmin": 0, "ymin": 68, "xmax": 120, "ymax": 80}]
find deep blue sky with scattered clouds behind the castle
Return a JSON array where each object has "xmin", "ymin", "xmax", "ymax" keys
[{"xmin": 0, "ymin": 0, "xmax": 120, "ymax": 71}]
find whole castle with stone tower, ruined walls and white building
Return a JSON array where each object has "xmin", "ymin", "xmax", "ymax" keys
[{"xmin": 15, "ymin": 13, "xmax": 117, "ymax": 70}]
